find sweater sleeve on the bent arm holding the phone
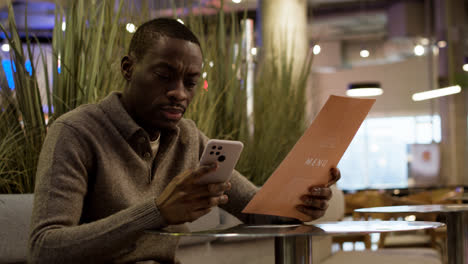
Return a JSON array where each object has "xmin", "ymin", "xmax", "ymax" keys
[{"xmin": 29, "ymin": 121, "xmax": 165, "ymax": 263}]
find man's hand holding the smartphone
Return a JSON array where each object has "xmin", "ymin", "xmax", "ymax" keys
[{"xmin": 156, "ymin": 164, "xmax": 231, "ymax": 225}]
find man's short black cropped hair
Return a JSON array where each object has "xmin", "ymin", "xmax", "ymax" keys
[{"xmin": 128, "ymin": 18, "xmax": 201, "ymax": 60}]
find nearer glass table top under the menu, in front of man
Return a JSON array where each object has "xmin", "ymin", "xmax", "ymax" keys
[{"xmin": 148, "ymin": 221, "xmax": 444, "ymax": 237}]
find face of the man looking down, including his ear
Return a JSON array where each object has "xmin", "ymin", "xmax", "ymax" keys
[{"xmin": 121, "ymin": 37, "xmax": 202, "ymax": 136}]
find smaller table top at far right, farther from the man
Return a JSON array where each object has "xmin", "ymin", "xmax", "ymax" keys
[{"xmin": 354, "ymin": 204, "xmax": 468, "ymax": 213}]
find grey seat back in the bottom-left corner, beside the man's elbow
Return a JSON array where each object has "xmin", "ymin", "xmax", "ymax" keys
[{"xmin": 0, "ymin": 194, "xmax": 34, "ymax": 263}]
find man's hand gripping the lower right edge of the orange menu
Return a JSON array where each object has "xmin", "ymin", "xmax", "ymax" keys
[{"xmin": 296, "ymin": 168, "xmax": 341, "ymax": 222}]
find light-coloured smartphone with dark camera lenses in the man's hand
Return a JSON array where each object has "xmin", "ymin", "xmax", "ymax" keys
[{"xmin": 198, "ymin": 139, "xmax": 244, "ymax": 184}]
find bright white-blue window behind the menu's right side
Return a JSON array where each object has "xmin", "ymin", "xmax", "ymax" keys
[{"xmin": 338, "ymin": 115, "xmax": 441, "ymax": 190}]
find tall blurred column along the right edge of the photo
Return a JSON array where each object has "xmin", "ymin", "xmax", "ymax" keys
[{"xmin": 436, "ymin": 0, "xmax": 468, "ymax": 185}]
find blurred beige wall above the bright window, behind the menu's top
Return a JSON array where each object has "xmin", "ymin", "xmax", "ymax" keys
[{"xmin": 307, "ymin": 56, "xmax": 438, "ymax": 122}]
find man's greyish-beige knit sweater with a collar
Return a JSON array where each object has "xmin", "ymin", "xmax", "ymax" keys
[{"xmin": 29, "ymin": 93, "xmax": 257, "ymax": 263}]
